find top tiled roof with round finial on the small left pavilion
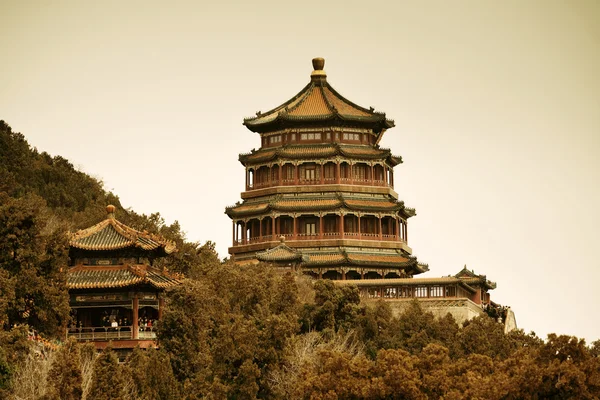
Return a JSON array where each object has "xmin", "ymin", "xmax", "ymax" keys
[{"xmin": 69, "ymin": 206, "xmax": 176, "ymax": 255}]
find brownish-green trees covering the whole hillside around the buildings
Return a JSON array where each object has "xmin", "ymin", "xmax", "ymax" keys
[{"xmin": 0, "ymin": 121, "xmax": 600, "ymax": 399}]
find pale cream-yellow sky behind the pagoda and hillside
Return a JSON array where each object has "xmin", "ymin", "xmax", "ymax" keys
[{"xmin": 0, "ymin": 0, "xmax": 600, "ymax": 343}]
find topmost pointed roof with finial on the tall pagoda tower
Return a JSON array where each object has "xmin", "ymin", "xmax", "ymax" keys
[{"xmin": 244, "ymin": 58, "xmax": 394, "ymax": 134}]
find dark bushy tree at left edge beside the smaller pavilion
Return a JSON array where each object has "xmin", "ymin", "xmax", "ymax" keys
[{"xmin": 0, "ymin": 193, "xmax": 69, "ymax": 336}]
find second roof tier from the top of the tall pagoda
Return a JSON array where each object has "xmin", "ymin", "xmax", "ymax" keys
[{"xmin": 239, "ymin": 143, "xmax": 402, "ymax": 166}]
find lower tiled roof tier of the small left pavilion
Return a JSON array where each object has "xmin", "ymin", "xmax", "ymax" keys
[{"xmin": 67, "ymin": 265, "xmax": 181, "ymax": 289}]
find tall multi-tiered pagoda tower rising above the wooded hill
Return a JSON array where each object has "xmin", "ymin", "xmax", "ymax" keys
[{"xmin": 225, "ymin": 58, "xmax": 428, "ymax": 280}]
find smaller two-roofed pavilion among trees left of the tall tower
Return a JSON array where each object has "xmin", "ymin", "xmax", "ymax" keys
[{"xmin": 67, "ymin": 205, "xmax": 180, "ymax": 349}]
